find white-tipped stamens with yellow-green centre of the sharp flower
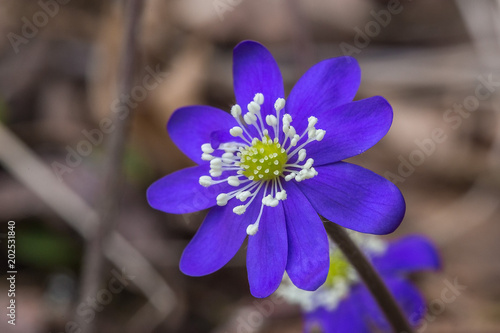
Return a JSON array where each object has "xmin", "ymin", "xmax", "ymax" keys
[{"xmin": 195, "ymin": 93, "xmax": 325, "ymax": 235}]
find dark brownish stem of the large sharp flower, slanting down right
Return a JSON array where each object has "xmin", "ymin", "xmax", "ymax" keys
[{"xmin": 321, "ymin": 217, "xmax": 413, "ymax": 333}]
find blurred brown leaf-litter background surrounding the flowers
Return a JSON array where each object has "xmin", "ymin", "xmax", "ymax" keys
[{"xmin": 0, "ymin": 0, "xmax": 500, "ymax": 333}]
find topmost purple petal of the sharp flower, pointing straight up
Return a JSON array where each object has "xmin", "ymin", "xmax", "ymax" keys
[{"xmin": 233, "ymin": 41, "xmax": 285, "ymax": 120}]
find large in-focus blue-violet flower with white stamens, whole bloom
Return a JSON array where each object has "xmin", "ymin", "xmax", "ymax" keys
[{"xmin": 147, "ymin": 41, "xmax": 405, "ymax": 297}]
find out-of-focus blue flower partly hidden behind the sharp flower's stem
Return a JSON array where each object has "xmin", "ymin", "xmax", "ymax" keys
[{"xmin": 277, "ymin": 235, "xmax": 440, "ymax": 333}]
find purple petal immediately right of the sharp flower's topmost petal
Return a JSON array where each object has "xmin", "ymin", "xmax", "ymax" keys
[{"xmin": 286, "ymin": 57, "xmax": 361, "ymax": 128}]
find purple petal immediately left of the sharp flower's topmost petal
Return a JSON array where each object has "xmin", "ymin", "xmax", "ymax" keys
[{"xmin": 167, "ymin": 105, "xmax": 237, "ymax": 164}]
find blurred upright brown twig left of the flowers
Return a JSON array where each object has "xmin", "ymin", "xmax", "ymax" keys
[{"xmin": 75, "ymin": 0, "xmax": 143, "ymax": 333}]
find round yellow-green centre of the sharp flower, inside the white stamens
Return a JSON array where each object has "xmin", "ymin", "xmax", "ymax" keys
[{"xmin": 240, "ymin": 135, "xmax": 288, "ymax": 180}]
